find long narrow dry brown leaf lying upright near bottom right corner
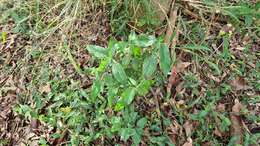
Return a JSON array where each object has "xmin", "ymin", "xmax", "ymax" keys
[{"xmin": 230, "ymin": 99, "xmax": 244, "ymax": 144}]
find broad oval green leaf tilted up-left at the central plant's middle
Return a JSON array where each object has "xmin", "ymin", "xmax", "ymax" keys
[{"xmin": 112, "ymin": 62, "xmax": 127, "ymax": 83}]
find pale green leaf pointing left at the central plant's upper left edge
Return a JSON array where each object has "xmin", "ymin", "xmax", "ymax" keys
[{"xmin": 86, "ymin": 45, "xmax": 109, "ymax": 58}]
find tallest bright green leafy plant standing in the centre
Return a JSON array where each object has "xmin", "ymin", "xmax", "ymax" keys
[{"xmin": 87, "ymin": 33, "xmax": 171, "ymax": 111}]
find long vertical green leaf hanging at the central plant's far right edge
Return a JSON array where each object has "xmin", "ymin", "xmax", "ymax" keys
[{"xmin": 159, "ymin": 45, "xmax": 171, "ymax": 75}]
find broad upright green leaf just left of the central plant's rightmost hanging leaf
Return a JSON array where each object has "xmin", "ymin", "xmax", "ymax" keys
[{"xmin": 143, "ymin": 55, "xmax": 157, "ymax": 78}]
